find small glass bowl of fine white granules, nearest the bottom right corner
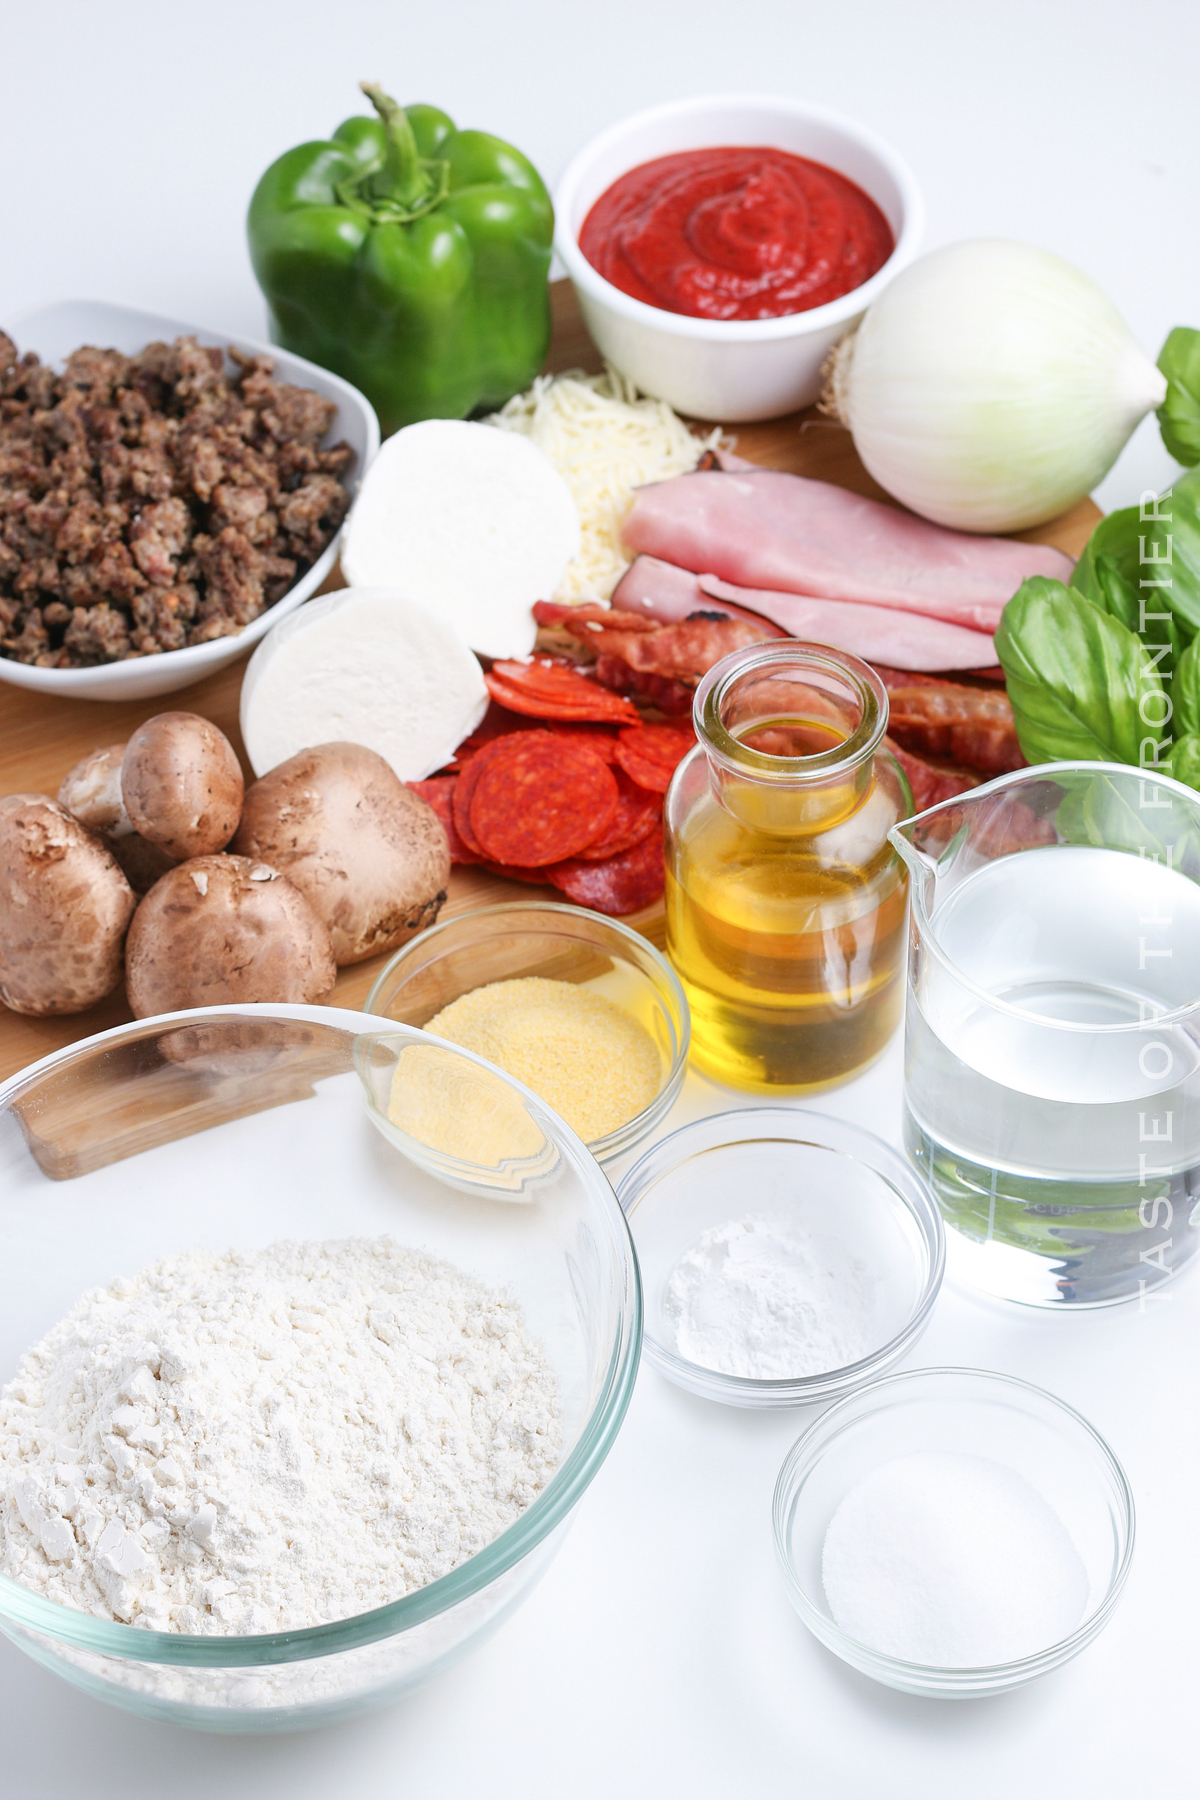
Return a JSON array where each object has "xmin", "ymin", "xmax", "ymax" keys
[{"xmin": 774, "ymin": 1368, "xmax": 1133, "ymax": 1699}]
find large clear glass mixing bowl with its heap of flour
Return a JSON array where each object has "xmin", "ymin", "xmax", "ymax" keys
[{"xmin": 0, "ymin": 1006, "xmax": 642, "ymax": 1732}]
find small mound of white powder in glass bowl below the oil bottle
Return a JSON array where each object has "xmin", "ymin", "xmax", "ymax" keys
[{"xmin": 662, "ymin": 1213, "xmax": 887, "ymax": 1381}]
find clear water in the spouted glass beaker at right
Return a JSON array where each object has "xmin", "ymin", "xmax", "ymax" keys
[{"xmin": 905, "ymin": 846, "xmax": 1200, "ymax": 1305}]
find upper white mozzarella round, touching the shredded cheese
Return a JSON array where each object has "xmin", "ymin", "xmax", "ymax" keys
[{"xmin": 342, "ymin": 419, "xmax": 579, "ymax": 657}]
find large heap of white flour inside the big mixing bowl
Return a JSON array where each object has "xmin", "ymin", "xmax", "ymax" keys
[{"xmin": 0, "ymin": 1238, "xmax": 561, "ymax": 1634}]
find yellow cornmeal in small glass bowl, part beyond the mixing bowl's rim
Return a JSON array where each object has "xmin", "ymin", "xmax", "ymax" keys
[{"xmin": 425, "ymin": 976, "xmax": 662, "ymax": 1143}]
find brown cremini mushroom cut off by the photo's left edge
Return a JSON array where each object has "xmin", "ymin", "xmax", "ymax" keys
[{"xmin": 0, "ymin": 794, "xmax": 137, "ymax": 1015}]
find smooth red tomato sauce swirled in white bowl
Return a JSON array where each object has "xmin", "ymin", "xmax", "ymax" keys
[{"xmin": 579, "ymin": 144, "xmax": 896, "ymax": 319}]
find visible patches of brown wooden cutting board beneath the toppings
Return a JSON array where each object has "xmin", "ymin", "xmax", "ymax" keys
[{"xmin": 0, "ymin": 281, "xmax": 1101, "ymax": 1078}]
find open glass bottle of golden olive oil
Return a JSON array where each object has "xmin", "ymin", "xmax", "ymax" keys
[{"xmin": 666, "ymin": 639, "xmax": 912, "ymax": 1093}]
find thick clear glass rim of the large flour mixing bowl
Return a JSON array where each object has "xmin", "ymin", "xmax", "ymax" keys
[{"xmin": 0, "ymin": 1004, "xmax": 644, "ymax": 1669}]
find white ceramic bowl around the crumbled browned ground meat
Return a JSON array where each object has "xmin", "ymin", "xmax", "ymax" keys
[{"xmin": 0, "ymin": 301, "xmax": 380, "ymax": 700}]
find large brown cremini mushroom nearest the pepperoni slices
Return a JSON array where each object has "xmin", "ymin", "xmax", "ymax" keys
[{"xmin": 232, "ymin": 743, "xmax": 450, "ymax": 963}]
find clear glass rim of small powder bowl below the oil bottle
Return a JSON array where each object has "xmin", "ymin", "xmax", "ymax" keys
[{"xmin": 617, "ymin": 1107, "xmax": 946, "ymax": 1417}]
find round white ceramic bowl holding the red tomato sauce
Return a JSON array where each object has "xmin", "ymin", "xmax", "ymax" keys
[{"xmin": 554, "ymin": 94, "xmax": 925, "ymax": 421}]
